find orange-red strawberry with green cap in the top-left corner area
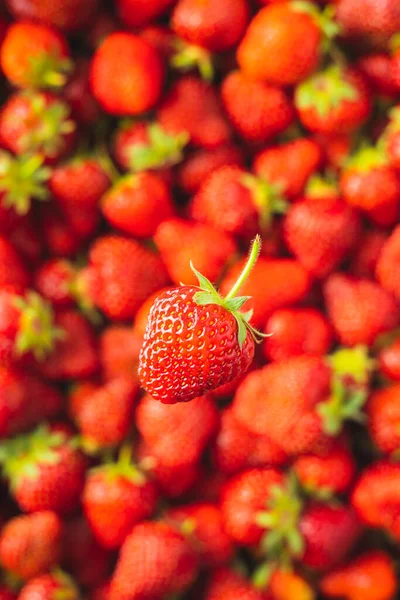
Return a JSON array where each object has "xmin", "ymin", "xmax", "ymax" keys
[{"xmin": 0, "ymin": 21, "xmax": 72, "ymax": 88}]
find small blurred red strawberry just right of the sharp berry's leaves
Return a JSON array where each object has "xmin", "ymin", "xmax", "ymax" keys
[{"xmin": 263, "ymin": 308, "xmax": 332, "ymax": 361}]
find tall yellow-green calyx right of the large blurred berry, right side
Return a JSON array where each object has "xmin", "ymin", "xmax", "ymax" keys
[{"xmin": 317, "ymin": 346, "xmax": 375, "ymax": 436}]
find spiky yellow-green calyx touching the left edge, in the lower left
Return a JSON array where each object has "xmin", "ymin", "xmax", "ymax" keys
[{"xmin": 0, "ymin": 425, "xmax": 65, "ymax": 489}]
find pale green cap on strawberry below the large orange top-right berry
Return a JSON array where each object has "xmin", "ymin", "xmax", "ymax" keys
[{"xmin": 295, "ymin": 64, "xmax": 358, "ymax": 117}]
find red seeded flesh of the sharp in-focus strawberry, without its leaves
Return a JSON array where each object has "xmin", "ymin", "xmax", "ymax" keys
[{"xmin": 139, "ymin": 286, "xmax": 254, "ymax": 404}]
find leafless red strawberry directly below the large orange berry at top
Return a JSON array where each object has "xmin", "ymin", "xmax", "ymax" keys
[{"xmin": 221, "ymin": 71, "xmax": 294, "ymax": 143}]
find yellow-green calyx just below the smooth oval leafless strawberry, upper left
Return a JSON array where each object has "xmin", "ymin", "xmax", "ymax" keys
[{"xmin": 129, "ymin": 123, "xmax": 189, "ymax": 172}]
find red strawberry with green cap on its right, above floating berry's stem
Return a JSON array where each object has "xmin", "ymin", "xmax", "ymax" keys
[{"xmin": 190, "ymin": 166, "xmax": 285, "ymax": 239}]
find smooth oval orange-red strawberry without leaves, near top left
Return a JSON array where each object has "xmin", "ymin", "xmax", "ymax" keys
[{"xmin": 90, "ymin": 32, "xmax": 164, "ymax": 115}]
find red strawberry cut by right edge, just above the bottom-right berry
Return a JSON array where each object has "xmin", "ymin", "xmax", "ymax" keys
[{"xmin": 351, "ymin": 460, "xmax": 400, "ymax": 540}]
